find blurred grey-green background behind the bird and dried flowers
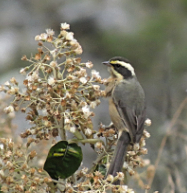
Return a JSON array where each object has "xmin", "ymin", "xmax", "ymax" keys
[{"xmin": 0, "ymin": 0, "xmax": 187, "ymax": 193}]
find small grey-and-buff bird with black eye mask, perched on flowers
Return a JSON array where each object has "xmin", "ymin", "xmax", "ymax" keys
[{"xmin": 103, "ymin": 57, "xmax": 146, "ymax": 184}]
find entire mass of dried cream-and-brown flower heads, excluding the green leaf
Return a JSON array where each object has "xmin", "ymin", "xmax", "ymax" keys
[{"xmin": 0, "ymin": 23, "xmax": 151, "ymax": 193}]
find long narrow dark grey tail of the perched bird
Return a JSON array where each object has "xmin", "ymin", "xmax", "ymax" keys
[{"xmin": 107, "ymin": 131, "xmax": 131, "ymax": 185}]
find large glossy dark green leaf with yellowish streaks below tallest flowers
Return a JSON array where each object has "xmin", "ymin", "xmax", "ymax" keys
[{"xmin": 44, "ymin": 141, "xmax": 82, "ymax": 180}]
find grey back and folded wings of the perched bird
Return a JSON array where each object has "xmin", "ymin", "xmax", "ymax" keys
[{"xmin": 113, "ymin": 79, "xmax": 146, "ymax": 143}]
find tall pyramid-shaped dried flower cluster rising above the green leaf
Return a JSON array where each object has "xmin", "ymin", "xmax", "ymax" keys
[{"xmin": 1, "ymin": 24, "xmax": 104, "ymax": 146}]
